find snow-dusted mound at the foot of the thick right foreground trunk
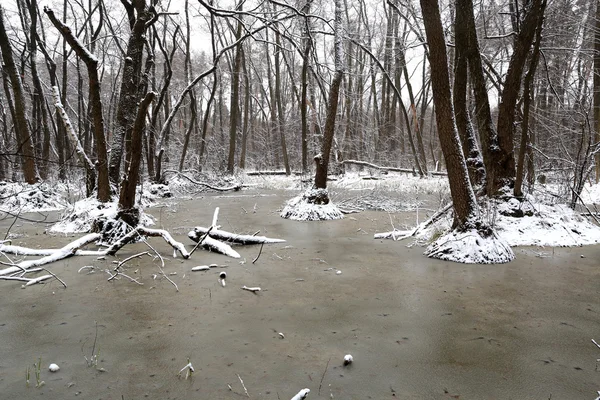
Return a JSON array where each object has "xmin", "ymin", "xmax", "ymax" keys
[{"xmin": 424, "ymin": 229, "xmax": 515, "ymax": 264}]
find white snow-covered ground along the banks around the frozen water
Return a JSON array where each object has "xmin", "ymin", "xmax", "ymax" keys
[{"xmin": 0, "ymin": 173, "xmax": 600, "ymax": 246}]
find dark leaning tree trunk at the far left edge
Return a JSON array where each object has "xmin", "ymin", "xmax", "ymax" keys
[{"xmin": 0, "ymin": 6, "xmax": 39, "ymax": 184}]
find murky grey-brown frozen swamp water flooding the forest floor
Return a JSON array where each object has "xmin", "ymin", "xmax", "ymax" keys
[{"xmin": 0, "ymin": 173, "xmax": 600, "ymax": 400}]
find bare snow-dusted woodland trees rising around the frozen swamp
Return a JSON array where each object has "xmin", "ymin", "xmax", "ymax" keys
[{"xmin": 0, "ymin": 0, "xmax": 600, "ymax": 263}]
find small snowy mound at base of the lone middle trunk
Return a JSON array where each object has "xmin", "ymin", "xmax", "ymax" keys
[{"xmin": 280, "ymin": 189, "xmax": 344, "ymax": 221}]
